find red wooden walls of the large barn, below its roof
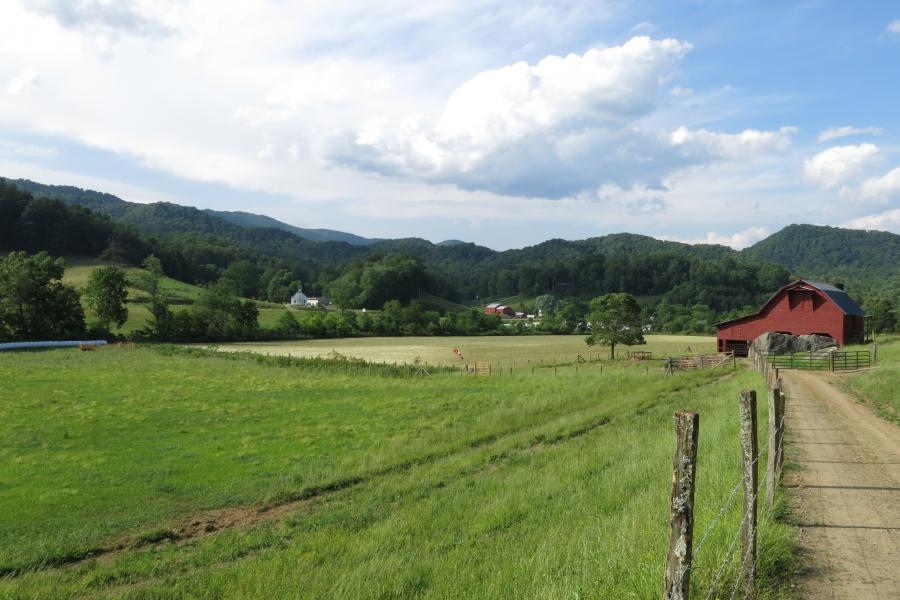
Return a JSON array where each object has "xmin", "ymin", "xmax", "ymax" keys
[{"xmin": 716, "ymin": 290, "xmax": 856, "ymax": 350}]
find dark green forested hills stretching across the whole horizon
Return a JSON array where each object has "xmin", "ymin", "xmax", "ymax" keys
[{"xmin": 7, "ymin": 176, "xmax": 900, "ymax": 331}]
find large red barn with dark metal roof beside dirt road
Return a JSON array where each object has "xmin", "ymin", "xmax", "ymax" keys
[{"xmin": 716, "ymin": 279, "xmax": 865, "ymax": 356}]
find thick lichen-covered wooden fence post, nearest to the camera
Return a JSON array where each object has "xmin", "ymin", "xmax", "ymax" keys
[{"xmin": 663, "ymin": 411, "xmax": 700, "ymax": 600}]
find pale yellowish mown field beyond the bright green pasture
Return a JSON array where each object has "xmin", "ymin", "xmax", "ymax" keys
[{"xmin": 217, "ymin": 335, "xmax": 716, "ymax": 372}]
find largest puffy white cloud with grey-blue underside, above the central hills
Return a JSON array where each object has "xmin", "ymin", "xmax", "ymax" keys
[{"xmin": 329, "ymin": 36, "xmax": 796, "ymax": 198}]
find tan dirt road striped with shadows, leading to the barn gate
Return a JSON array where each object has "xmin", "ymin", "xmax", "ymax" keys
[{"xmin": 782, "ymin": 371, "xmax": 900, "ymax": 600}]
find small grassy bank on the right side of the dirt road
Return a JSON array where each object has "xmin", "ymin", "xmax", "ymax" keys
[{"xmin": 842, "ymin": 337, "xmax": 900, "ymax": 424}]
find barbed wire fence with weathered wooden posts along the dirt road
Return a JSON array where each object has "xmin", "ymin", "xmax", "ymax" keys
[{"xmin": 663, "ymin": 365, "xmax": 785, "ymax": 600}]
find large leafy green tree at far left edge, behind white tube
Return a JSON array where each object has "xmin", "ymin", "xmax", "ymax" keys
[{"xmin": 0, "ymin": 252, "xmax": 84, "ymax": 341}]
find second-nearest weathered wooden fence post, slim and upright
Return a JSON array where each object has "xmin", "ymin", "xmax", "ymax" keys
[{"xmin": 741, "ymin": 390, "xmax": 759, "ymax": 599}]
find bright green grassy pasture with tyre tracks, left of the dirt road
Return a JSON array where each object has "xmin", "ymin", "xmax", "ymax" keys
[{"xmin": 0, "ymin": 346, "xmax": 792, "ymax": 598}]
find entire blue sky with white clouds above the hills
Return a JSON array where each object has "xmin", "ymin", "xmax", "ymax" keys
[{"xmin": 0, "ymin": 0, "xmax": 900, "ymax": 249}]
